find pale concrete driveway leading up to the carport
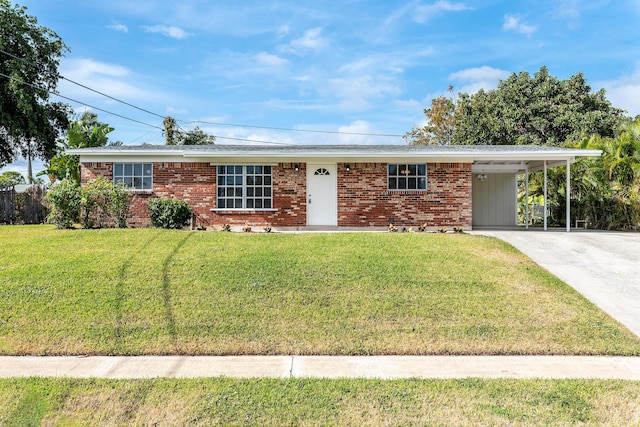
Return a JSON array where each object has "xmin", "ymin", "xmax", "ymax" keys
[{"xmin": 473, "ymin": 229, "xmax": 640, "ymax": 336}]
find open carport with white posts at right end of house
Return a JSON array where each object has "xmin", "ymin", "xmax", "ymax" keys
[{"xmin": 472, "ymin": 146, "xmax": 602, "ymax": 231}]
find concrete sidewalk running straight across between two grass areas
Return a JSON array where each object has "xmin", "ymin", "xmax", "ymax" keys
[{"xmin": 0, "ymin": 356, "xmax": 640, "ymax": 380}]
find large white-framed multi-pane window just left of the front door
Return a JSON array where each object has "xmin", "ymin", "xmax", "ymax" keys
[{"xmin": 217, "ymin": 166, "xmax": 272, "ymax": 209}]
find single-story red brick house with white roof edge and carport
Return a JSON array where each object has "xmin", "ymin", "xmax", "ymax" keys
[{"xmin": 67, "ymin": 145, "xmax": 600, "ymax": 230}]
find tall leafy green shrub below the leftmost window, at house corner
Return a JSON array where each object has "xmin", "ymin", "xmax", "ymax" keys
[{"xmin": 81, "ymin": 177, "xmax": 129, "ymax": 228}]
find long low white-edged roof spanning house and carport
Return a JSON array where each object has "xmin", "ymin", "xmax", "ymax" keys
[{"xmin": 67, "ymin": 144, "xmax": 601, "ymax": 173}]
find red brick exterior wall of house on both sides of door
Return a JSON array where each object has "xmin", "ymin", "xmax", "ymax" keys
[{"xmin": 82, "ymin": 162, "xmax": 472, "ymax": 228}]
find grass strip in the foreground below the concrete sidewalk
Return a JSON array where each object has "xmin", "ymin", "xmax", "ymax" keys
[{"xmin": 0, "ymin": 378, "xmax": 640, "ymax": 426}]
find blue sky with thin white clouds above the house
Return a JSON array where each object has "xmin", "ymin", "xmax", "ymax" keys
[{"xmin": 5, "ymin": 0, "xmax": 640, "ymax": 176}]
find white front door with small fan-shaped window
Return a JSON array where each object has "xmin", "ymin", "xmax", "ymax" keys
[{"xmin": 307, "ymin": 164, "xmax": 338, "ymax": 225}]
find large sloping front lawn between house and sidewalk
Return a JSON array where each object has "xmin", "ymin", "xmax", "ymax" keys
[{"xmin": 0, "ymin": 226, "xmax": 640, "ymax": 355}]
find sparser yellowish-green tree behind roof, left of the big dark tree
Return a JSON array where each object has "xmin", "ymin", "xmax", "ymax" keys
[{"xmin": 403, "ymin": 86, "xmax": 457, "ymax": 145}]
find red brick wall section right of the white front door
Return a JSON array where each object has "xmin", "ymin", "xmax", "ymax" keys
[{"xmin": 338, "ymin": 163, "xmax": 472, "ymax": 228}]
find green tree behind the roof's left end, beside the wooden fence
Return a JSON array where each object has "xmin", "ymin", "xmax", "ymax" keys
[{"xmin": 39, "ymin": 111, "xmax": 114, "ymax": 183}]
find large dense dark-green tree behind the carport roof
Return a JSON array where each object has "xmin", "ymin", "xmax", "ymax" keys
[{"xmin": 452, "ymin": 66, "xmax": 623, "ymax": 146}]
